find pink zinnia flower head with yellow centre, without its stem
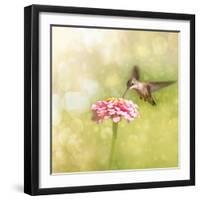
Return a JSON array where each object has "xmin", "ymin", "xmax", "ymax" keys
[{"xmin": 91, "ymin": 98, "xmax": 139, "ymax": 123}]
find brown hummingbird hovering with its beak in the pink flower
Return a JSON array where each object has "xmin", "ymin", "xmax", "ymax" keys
[{"xmin": 122, "ymin": 66, "xmax": 176, "ymax": 105}]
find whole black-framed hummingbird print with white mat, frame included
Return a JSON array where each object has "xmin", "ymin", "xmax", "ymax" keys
[{"xmin": 24, "ymin": 5, "xmax": 195, "ymax": 195}]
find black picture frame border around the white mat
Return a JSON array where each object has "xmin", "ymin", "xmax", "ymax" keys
[{"xmin": 24, "ymin": 5, "xmax": 195, "ymax": 195}]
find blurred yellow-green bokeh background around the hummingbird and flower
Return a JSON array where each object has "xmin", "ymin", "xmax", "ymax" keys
[{"xmin": 52, "ymin": 27, "xmax": 178, "ymax": 173}]
